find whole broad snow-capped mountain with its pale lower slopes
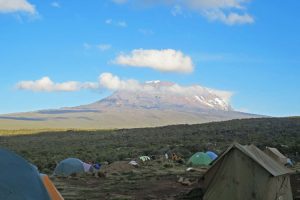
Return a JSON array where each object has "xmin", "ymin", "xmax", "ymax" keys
[{"xmin": 0, "ymin": 81, "xmax": 257, "ymax": 129}]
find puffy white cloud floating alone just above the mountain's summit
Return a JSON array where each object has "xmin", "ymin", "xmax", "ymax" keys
[{"xmin": 113, "ymin": 49, "xmax": 194, "ymax": 73}]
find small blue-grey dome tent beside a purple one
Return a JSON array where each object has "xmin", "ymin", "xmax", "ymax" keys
[{"xmin": 53, "ymin": 158, "xmax": 85, "ymax": 176}]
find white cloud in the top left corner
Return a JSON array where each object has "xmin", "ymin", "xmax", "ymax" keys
[{"xmin": 0, "ymin": 0, "xmax": 36, "ymax": 14}]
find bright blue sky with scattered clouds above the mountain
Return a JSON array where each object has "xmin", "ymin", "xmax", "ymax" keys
[{"xmin": 0, "ymin": 0, "xmax": 300, "ymax": 116}]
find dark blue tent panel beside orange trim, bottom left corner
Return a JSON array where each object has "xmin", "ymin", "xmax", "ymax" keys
[{"xmin": 0, "ymin": 149, "xmax": 50, "ymax": 200}]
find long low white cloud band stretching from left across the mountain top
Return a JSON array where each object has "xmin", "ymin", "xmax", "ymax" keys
[{"xmin": 16, "ymin": 72, "xmax": 233, "ymax": 102}]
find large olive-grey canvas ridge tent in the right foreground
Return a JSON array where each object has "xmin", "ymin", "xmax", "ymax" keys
[{"xmin": 203, "ymin": 143, "xmax": 293, "ymax": 200}]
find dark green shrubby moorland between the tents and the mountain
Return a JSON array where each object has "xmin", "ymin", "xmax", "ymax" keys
[{"xmin": 0, "ymin": 117, "xmax": 300, "ymax": 173}]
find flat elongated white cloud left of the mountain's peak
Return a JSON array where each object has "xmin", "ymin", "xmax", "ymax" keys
[{"xmin": 16, "ymin": 76, "xmax": 98, "ymax": 92}]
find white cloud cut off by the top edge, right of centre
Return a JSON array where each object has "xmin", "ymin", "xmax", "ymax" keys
[{"xmin": 112, "ymin": 0, "xmax": 254, "ymax": 25}]
